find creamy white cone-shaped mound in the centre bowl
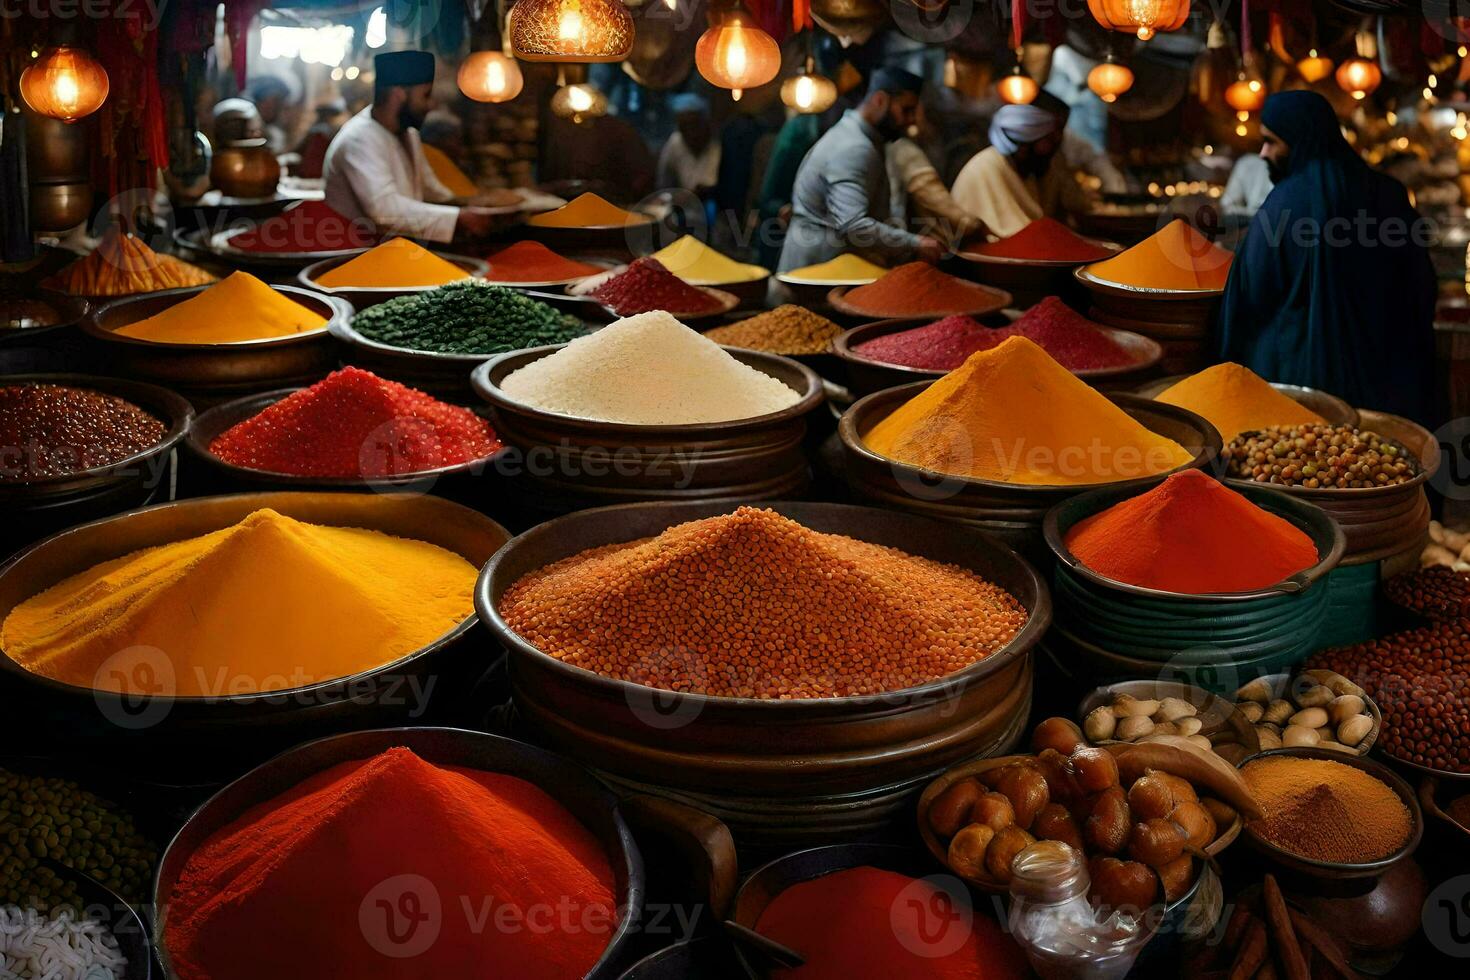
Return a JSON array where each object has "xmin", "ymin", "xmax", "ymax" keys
[{"xmin": 500, "ymin": 310, "xmax": 801, "ymax": 425}]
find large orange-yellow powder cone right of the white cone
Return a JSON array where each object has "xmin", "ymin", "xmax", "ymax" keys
[{"xmin": 863, "ymin": 336, "xmax": 1192, "ymax": 486}]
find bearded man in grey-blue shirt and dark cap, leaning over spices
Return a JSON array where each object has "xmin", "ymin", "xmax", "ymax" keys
[{"xmin": 778, "ymin": 68, "xmax": 945, "ymax": 272}]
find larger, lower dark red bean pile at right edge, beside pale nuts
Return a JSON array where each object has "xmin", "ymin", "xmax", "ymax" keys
[{"xmin": 1308, "ymin": 620, "xmax": 1470, "ymax": 773}]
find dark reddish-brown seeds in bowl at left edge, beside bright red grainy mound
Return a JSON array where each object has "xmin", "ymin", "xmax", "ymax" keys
[{"xmin": 0, "ymin": 385, "xmax": 168, "ymax": 482}]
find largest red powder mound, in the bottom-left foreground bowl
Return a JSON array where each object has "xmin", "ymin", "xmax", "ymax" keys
[{"xmin": 165, "ymin": 748, "xmax": 617, "ymax": 980}]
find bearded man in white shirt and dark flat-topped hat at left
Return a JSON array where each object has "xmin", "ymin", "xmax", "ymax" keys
[{"xmin": 322, "ymin": 51, "xmax": 503, "ymax": 242}]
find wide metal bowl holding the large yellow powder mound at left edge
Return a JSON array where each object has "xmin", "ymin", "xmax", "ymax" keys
[{"xmin": 0, "ymin": 494, "xmax": 510, "ymax": 767}]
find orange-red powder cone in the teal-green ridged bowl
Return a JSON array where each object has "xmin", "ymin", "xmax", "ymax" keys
[{"xmin": 1066, "ymin": 470, "xmax": 1317, "ymax": 595}]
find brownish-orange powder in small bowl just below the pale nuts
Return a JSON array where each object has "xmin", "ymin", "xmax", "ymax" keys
[{"xmin": 1241, "ymin": 755, "xmax": 1413, "ymax": 864}]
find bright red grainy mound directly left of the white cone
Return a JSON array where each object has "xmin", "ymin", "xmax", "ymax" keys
[{"xmin": 209, "ymin": 367, "xmax": 500, "ymax": 478}]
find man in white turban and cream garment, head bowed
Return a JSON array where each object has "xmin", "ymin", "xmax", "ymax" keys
[{"xmin": 951, "ymin": 104, "xmax": 1066, "ymax": 238}]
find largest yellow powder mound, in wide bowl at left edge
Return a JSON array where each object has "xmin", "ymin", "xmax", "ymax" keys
[{"xmin": 0, "ymin": 510, "xmax": 476, "ymax": 696}]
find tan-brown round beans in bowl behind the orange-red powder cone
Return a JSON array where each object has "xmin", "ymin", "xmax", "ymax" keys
[{"xmin": 1225, "ymin": 425, "xmax": 1419, "ymax": 489}]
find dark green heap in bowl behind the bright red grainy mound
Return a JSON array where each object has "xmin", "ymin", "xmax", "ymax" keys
[{"xmin": 353, "ymin": 279, "xmax": 587, "ymax": 354}]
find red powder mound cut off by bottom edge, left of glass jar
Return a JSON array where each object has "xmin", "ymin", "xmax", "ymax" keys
[{"xmin": 756, "ymin": 867, "xmax": 1029, "ymax": 980}]
